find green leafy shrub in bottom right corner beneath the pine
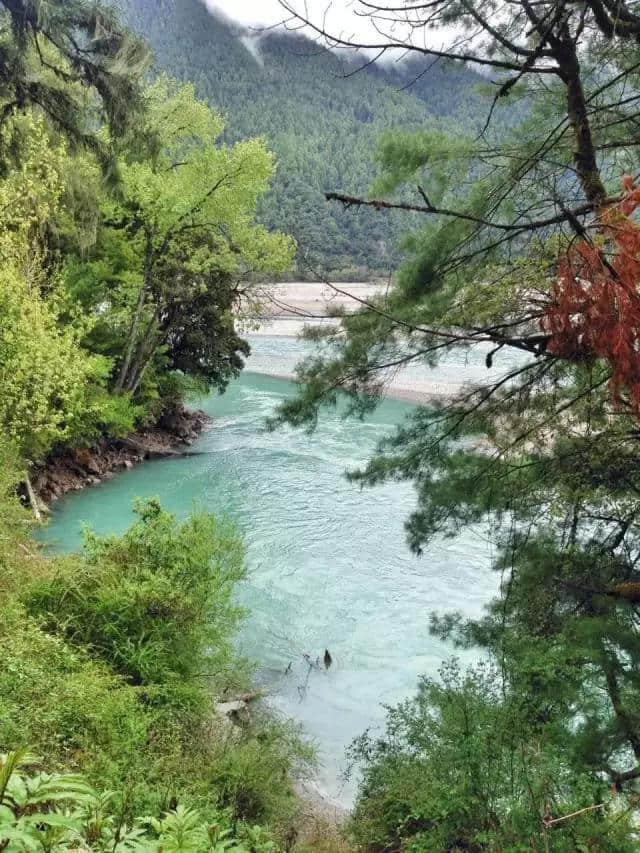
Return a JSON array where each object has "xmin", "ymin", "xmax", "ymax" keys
[{"xmin": 351, "ymin": 663, "xmax": 637, "ymax": 853}]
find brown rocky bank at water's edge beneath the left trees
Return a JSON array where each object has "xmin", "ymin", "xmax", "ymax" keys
[{"xmin": 32, "ymin": 409, "xmax": 212, "ymax": 512}]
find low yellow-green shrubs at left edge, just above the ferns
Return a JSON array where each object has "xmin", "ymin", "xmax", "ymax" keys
[{"xmin": 0, "ymin": 602, "xmax": 154, "ymax": 783}]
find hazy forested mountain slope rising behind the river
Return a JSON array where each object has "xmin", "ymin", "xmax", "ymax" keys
[{"xmin": 122, "ymin": 0, "xmax": 486, "ymax": 275}]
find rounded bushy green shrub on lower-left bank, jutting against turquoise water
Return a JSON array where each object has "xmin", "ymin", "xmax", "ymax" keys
[{"xmin": 27, "ymin": 501, "xmax": 245, "ymax": 688}]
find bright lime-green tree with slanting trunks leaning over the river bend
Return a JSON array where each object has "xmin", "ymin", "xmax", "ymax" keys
[{"xmin": 103, "ymin": 78, "xmax": 293, "ymax": 393}]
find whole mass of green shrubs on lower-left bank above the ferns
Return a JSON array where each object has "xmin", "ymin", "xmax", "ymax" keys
[{"xmin": 16, "ymin": 501, "xmax": 312, "ymax": 827}]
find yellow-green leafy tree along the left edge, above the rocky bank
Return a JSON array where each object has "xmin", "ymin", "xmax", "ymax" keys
[{"xmin": 0, "ymin": 114, "xmax": 126, "ymax": 462}]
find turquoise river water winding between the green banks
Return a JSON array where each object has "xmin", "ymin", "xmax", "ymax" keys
[{"xmin": 43, "ymin": 343, "xmax": 496, "ymax": 802}]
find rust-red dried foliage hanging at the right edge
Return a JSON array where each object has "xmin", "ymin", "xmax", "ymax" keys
[{"xmin": 542, "ymin": 175, "xmax": 640, "ymax": 415}]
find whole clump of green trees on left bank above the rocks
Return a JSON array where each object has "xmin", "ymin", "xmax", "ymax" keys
[{"xmin": 0, "ymin": 20, "xmax": 295, "ymax": 463}]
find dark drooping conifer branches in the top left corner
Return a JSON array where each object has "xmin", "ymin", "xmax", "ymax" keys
[{"xmin": 0, "ymin": 0, "xmax": 149, "ymax": 166}]
